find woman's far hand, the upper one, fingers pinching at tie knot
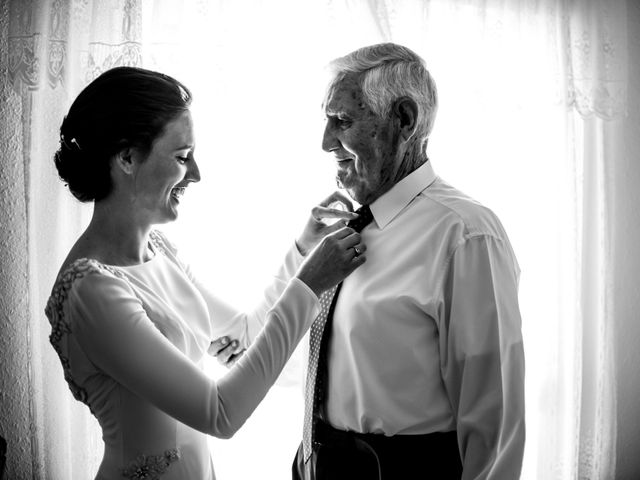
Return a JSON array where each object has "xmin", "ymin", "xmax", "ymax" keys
[{"xmin": 296, "ymin": 192, "xmax": 358, "ymax": 256}]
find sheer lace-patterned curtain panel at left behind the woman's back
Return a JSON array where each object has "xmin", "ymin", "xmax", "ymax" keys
[{"xmin": 2, "ymin": 0, "xmax": 141, "ymax": 479}]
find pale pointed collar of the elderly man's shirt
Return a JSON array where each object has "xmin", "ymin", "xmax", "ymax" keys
[{"xmin": 370, "ymin": 161, "xmax": 436, "ymax": 229}]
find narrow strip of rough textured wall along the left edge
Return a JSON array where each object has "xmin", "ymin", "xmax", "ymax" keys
[{"xmin": 0, "ymin": 2, "xmax": 32, "ymax": 479}]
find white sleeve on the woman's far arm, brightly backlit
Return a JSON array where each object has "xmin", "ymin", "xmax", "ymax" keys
[{"xmin": 184, "ymin": 245, "xmax": 303, "ymax": 350}]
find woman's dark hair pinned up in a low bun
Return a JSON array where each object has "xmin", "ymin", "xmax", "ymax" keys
[{"xmin": 54, "ymin": 67, "xmax": 191, "ymax": 202}]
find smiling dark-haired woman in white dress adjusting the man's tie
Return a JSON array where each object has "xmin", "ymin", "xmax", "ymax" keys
[{"xmin": 46, "ymin": 67, "xmax": 365, "ymax": 480}]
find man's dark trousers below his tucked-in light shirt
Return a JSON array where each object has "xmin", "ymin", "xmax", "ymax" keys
[{"xmin": 292, "ymin": 422, "xmax": 462, "ymax": 480}]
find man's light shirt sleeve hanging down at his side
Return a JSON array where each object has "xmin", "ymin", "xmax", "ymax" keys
[{"xmin": 440, "ymin": 235, "xmax": 525, "ymax": 480}]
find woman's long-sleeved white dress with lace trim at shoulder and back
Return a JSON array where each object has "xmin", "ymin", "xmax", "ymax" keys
[{"xmin": 46, "ymin": 232, "xmax": 319, "ymax": 480}]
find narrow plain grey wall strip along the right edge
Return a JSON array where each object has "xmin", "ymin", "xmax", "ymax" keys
[{"xmin": 610, "ymin": 1, "xmax": 640, "ymax": 480}]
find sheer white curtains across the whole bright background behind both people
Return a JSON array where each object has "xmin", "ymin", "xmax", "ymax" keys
[{"xmin": 2, "ymin": 0, "xmax": 627, "ymax": 480}]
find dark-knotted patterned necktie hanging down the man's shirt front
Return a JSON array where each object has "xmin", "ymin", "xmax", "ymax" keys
[{"xmin": 302, "ymin": 205, "xmax": 373, "ymax": 462}]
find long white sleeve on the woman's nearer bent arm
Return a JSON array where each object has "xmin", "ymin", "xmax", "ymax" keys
[{"xmin": 67, "ymin": 273, "xmax": 319, "ymax": 438}]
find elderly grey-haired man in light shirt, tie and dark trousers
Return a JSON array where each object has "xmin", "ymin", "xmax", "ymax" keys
[{"xmin": 293, "ymin": 43, "xmax": 525, "ymax": 480}]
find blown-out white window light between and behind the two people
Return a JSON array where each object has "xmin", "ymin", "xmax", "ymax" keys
[{"xmin": 143, "ymin": 0, "xmax": 573, "ymax": 479}]
